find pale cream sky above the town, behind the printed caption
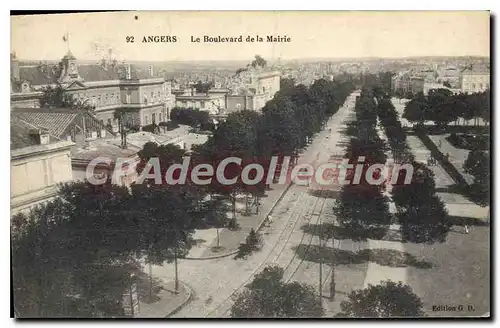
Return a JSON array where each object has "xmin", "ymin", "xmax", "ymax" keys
[{"xmin": 11, "ymin": 11, "xmax": 490, "ymax": 61}]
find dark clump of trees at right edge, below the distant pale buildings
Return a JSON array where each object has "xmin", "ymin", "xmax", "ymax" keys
[{"xmin": 403, "ymin": 89, "xmax": 491, "ymax": 127}]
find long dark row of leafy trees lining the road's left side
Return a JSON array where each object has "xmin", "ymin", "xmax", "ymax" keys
[{"xmin": 12, "ymin": 80, "xmax": 353, "ymax": 317}]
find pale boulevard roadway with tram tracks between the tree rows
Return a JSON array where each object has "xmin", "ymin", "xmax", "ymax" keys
[{"xmin": 153, "ymin": 90, "xmax": 362, "ymax": 317}]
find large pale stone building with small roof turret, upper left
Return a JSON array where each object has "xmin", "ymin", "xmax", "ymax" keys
[{"xmin": 11, "ymin": 51, "xmax": 175, "ymax": 130}]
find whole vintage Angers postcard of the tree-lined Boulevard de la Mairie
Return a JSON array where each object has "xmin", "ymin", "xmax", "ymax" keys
[{"xmin": 10, "ymin": 11, "xmax": 491, "ymax": 319}]
